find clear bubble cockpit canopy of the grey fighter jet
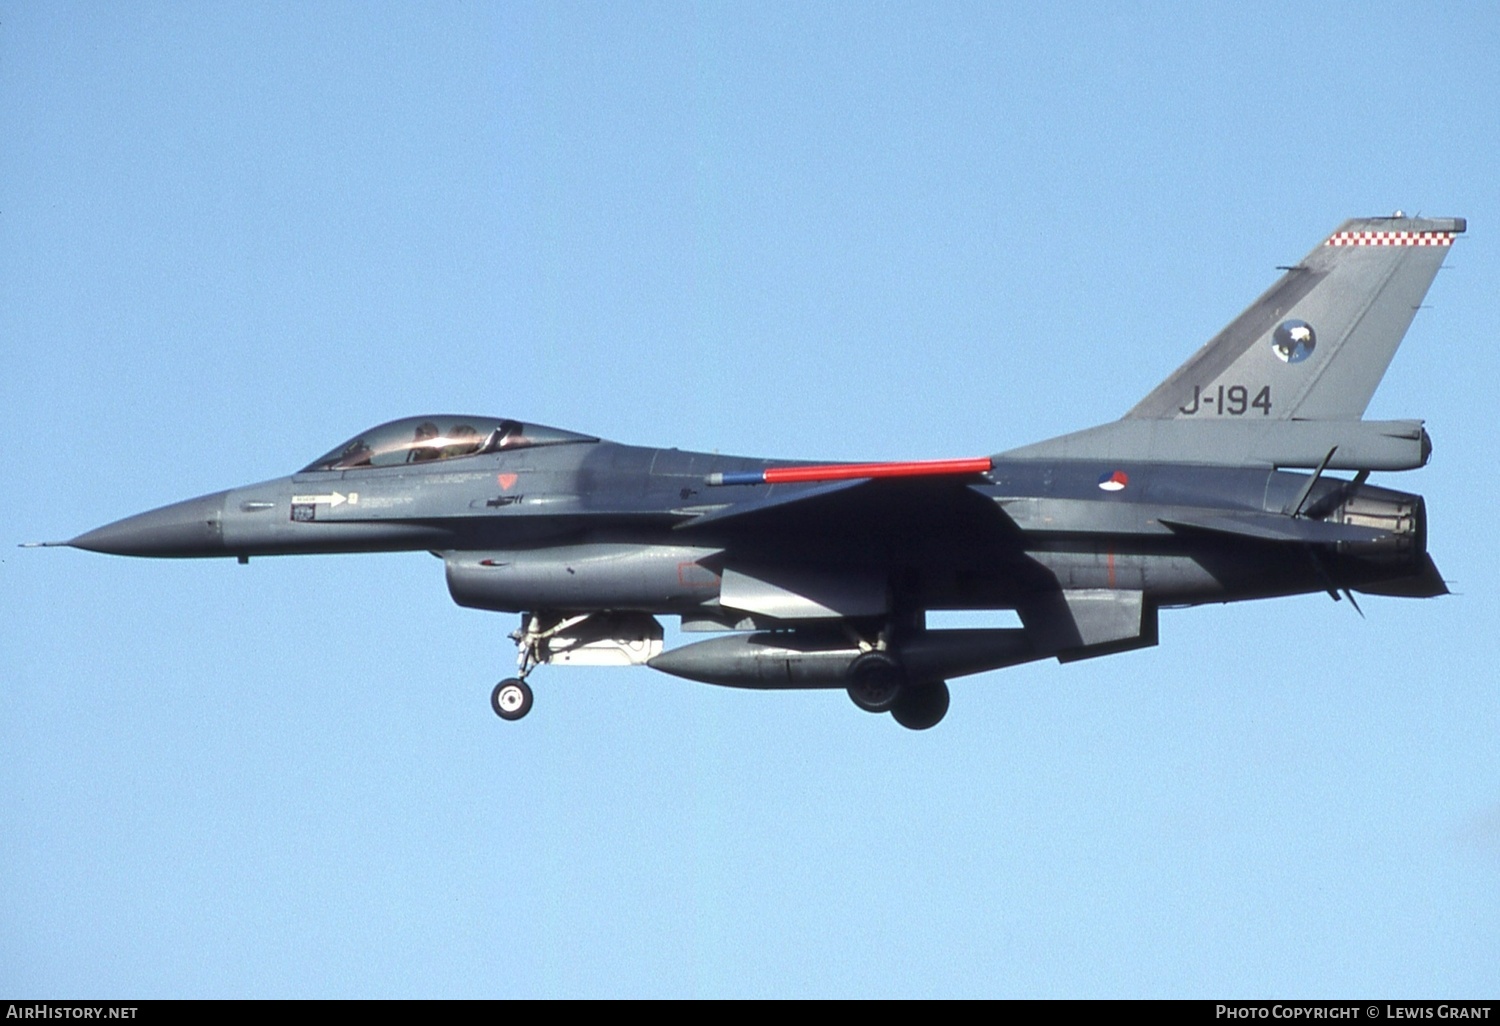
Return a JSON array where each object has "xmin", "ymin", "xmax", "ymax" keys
[{"xmin": 302, "ymin": 416, "xmax": 599, "ymax": 474}]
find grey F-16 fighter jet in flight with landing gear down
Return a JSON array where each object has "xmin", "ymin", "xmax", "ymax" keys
[{"xmin": 43, "ymin": 213, "xmax": 1464, "ymax": 729}]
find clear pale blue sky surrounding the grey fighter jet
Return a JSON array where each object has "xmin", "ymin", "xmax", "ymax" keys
[{"xmin": 0, "ymin": 2, "xmax": 1500, "ymax": 998}]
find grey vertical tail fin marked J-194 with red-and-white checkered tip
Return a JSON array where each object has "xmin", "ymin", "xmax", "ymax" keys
[{"xmin": 1125, "ymin": 215, "xmax": 1466, "ymax": 420}]
